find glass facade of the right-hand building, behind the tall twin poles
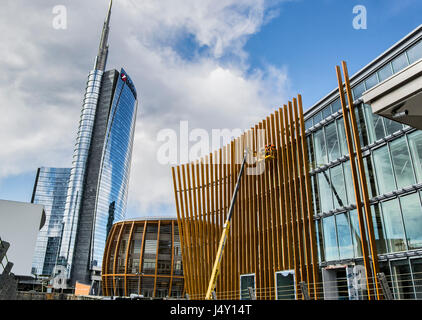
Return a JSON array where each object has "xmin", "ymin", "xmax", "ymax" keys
[{"xmin": 305, "ymin": 34, "xmax": 422, "ymax": 299}]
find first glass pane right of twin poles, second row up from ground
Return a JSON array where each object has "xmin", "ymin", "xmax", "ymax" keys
[{"xmin": 382, "ymin": 199, "xmax": 406, "ymax": 252}]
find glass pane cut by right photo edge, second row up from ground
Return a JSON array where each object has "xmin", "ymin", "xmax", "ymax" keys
[{"xmin": 400, "ymin": 193, "xmax": 422, "ymax": 249}]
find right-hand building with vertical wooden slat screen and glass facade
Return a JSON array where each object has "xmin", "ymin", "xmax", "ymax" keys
[{"xmin": 172, "ymin": 25, "xmax": 422, "ymax": 300}]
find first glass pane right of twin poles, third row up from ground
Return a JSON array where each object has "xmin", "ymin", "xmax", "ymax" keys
[{"xmin": 373, "ymin": 146, "xmax": 397, "ymax": 194}]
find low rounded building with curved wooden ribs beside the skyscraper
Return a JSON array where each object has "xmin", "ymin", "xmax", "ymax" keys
[{"xmin": 102, "ymin": 218, "xmax": 184, "ymax": 298}]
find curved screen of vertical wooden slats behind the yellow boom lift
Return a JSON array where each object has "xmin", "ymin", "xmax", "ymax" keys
[{"xmin": 172, "ymin": 95, "xmax": 319, "ymax": 299}]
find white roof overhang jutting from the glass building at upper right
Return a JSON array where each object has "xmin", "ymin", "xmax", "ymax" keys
[{"xmin": 362, "ymin": 59, "xmax": 422, "ymax": 129}]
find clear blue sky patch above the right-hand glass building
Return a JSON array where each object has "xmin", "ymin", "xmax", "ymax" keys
[{"xmin": 245, "ymin": 0, "xmax": 422, "ymax": 108}]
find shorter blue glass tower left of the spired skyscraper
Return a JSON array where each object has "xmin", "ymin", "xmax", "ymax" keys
[{"xmin": 31, "ymin": 167, "xmax": 70, "ymax": 276}]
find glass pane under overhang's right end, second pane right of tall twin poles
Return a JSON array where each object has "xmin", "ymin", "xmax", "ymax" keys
[{"xmin": 390, "ymin": 137, "xmax": 415, "ymax": 189}]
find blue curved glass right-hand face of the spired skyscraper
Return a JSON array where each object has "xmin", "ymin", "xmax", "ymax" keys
[{"xmin": 91, "ymin": 69, "xmax": 137, "ymax": 267}]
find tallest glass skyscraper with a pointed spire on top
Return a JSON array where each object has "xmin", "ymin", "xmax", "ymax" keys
[{"xmin": 58, "ymin": 1, "xmax": 138, "ymax": 286}]
